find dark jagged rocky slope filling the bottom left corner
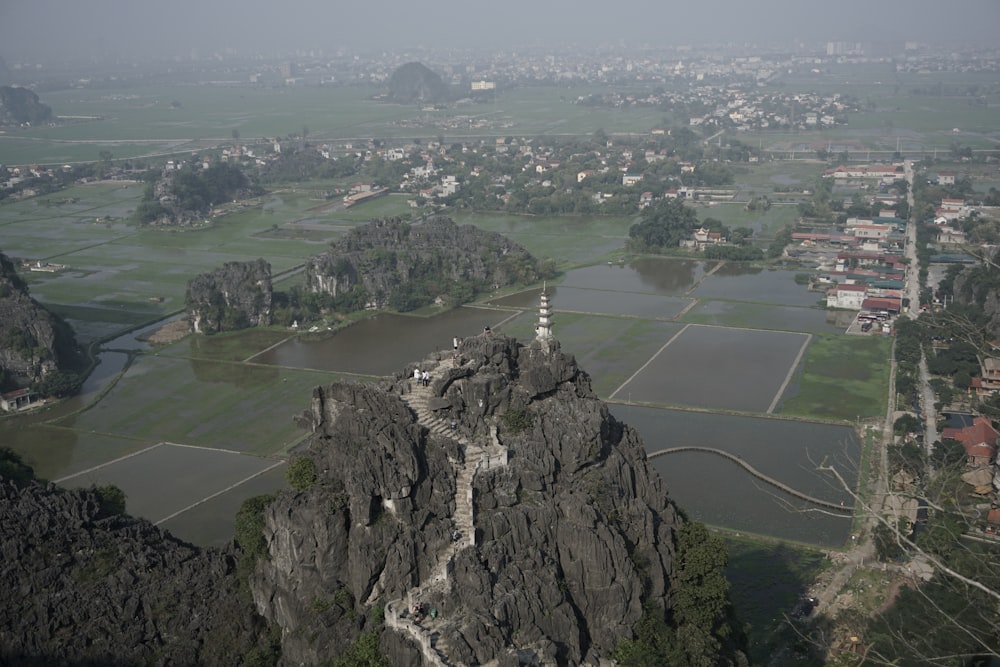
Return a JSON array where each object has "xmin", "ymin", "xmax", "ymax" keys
[{"xmin": 0, "ymin": 479, "xmax": 269, "ymax": 666}]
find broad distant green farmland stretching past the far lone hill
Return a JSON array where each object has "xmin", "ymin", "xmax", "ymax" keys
[{"xmin": 7, "ymin": 83, "xmax": 670, "ymax": 164}]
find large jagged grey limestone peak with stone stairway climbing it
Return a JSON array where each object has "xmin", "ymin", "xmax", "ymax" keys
[{"xmin": 252, "ymin": 333, "xmax": 681, "ymax": 665}]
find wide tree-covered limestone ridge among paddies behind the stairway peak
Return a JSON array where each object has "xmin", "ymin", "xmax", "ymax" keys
[{"xmin": 306, "ymin": 217, "xmax": 539, "ymax": 310}]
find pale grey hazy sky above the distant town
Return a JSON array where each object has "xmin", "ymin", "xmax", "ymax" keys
[{"xmin": 0, "ymin": 0, "xmax": 1000, "ymax": 64}]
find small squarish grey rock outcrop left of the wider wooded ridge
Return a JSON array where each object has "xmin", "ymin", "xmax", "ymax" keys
[{"xmin": 185, "ymin": 259, "xmax": 273, "ymax": 333}]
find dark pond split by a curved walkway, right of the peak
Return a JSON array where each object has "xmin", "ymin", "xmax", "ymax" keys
[{"xmin": 611, "ymin": 405, "xmax": 861, "ymax": 547}]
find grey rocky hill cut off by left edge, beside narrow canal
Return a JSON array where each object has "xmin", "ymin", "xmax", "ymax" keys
[{"xmin": 0, "ymin": 253, "xmax": 76, "ymax": 387}]
